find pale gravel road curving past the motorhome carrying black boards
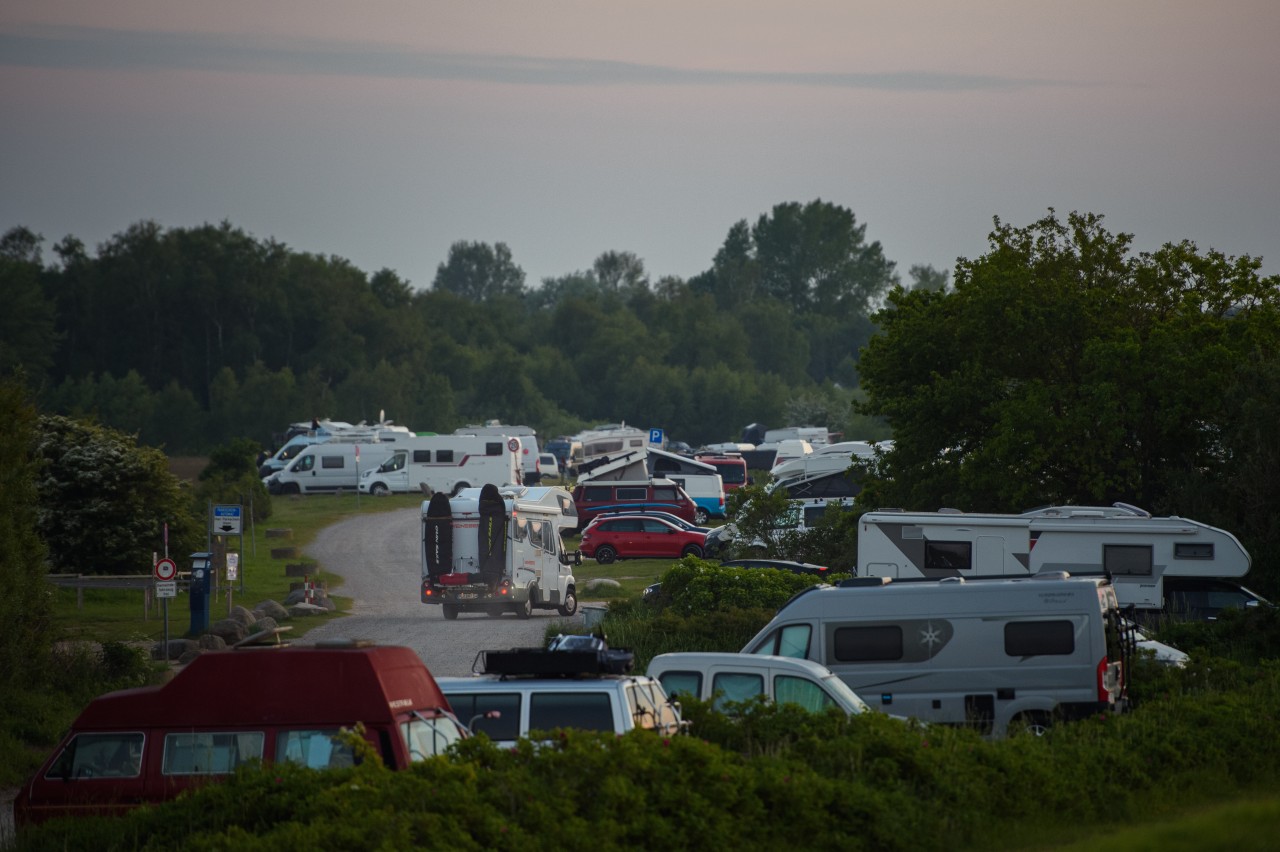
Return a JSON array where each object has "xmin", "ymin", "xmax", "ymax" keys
[{"xmin": 297, "ymin": 508, "xmax": 582, "ymax": 675}]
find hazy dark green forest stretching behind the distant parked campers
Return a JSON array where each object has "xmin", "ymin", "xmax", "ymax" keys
[{"xmin": 0, "ymin": 200, "xmax": 921, "ymax": 455}]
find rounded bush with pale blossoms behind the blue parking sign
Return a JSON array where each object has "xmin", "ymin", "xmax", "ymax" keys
[{"xmin": 36, "ymin": 414, "xmax": 204, "ymax": 574}]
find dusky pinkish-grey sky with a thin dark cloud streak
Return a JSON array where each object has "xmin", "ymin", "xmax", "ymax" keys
[{"xmin": 0, "ymin": 0, "xmax": 1280, "ymax": 288}]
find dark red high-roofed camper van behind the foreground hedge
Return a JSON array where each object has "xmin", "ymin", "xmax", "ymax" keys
[{"xmin": 13, "ymin": 642, "xmax": 467, "ymax": 828}]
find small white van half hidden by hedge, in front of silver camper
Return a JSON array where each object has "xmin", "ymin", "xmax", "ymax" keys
[{"xmin": 648, "ymin": 652, "xmax": 869, "ymax": 715}]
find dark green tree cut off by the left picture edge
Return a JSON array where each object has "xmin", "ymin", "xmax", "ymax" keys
[{"xmin": 0, "ymin": 375, "xmax": 52, "ymax": 690}]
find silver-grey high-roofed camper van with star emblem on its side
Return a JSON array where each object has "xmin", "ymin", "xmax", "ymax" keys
[{"xmin": 742, "ymin": 574, "xmax": 1133, "ymax": 737}]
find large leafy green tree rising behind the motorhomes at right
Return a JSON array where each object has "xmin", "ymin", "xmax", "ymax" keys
[{"xmin": 859, "ymin": 210, "xmax": 1280, "ymax": 530}]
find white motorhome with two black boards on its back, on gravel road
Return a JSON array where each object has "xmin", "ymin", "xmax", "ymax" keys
[{"xmin": 420, "ymin": 484, "xmax": 582, "ymax": 620}]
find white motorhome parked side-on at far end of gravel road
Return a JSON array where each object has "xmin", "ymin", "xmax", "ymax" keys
[{"xmin": 360, "ymin": 435, "xmax": 524, "ymax": 495}]
